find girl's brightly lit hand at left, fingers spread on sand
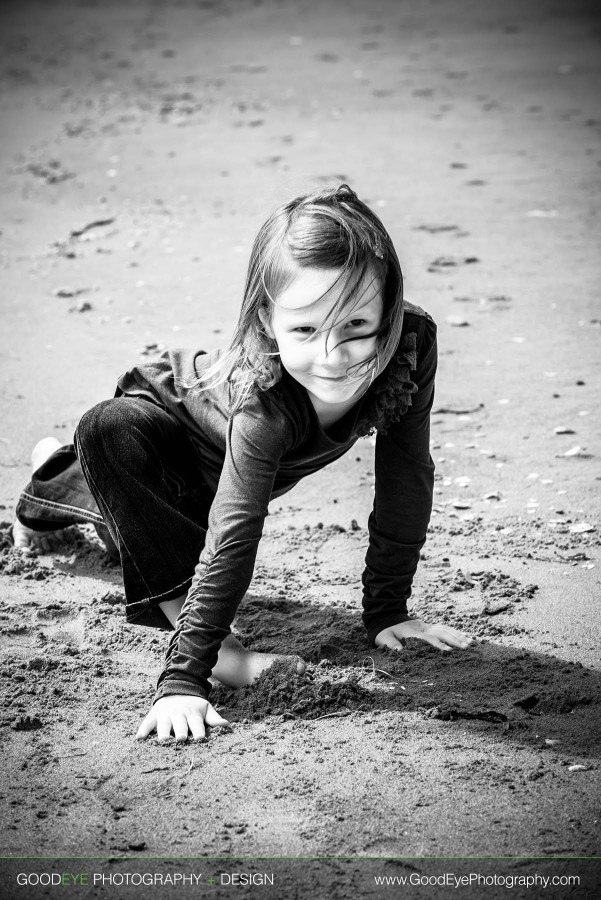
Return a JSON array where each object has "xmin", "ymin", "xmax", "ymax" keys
[{"xmin": 136, "ymin": 694, "xmax": 232, "ymax": 741}]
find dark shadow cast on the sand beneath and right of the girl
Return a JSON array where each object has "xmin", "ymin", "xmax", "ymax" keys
[{"xmin": 212, "ymin": 595, "xmax": 601, "ymax": 761}]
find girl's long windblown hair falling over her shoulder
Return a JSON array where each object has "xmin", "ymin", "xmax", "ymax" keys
[{"xmin": 187, "ymin": 184, "xmax": 403, "ymax": 413}]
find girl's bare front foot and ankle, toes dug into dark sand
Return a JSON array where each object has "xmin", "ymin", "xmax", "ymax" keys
[{"xmin": 159, "ymin": 596, "xmax": 307, "ymax": 687}]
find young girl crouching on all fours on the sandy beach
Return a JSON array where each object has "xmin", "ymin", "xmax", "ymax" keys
[{"xmin": 14, "ymin": 185, "xmax": 471, "ymax": 740}]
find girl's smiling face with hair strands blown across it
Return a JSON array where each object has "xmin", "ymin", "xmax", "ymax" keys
[{"xmin": 259, "ymin": 267, "xmax": 384, "ymax": 416}]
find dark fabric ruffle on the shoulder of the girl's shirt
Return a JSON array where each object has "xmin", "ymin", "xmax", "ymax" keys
[{"xmin": 355, "ymin": 331, "xmax": 418, "ymax": 437}]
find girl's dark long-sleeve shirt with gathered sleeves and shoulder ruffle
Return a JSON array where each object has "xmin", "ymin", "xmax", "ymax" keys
[{"xmin": 119, "ymin": 304, "xmax": 437, "ymax": 699}]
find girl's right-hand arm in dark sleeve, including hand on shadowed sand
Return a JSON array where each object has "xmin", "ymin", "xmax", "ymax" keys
[{"xmin": 363, "ymin": 315, "xmax": 470, "ymax": 649}]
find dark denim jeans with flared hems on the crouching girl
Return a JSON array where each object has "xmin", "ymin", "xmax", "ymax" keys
[{"xmin": 17, "ymin": 396, "xmax": 214, "ymax": 629}]
